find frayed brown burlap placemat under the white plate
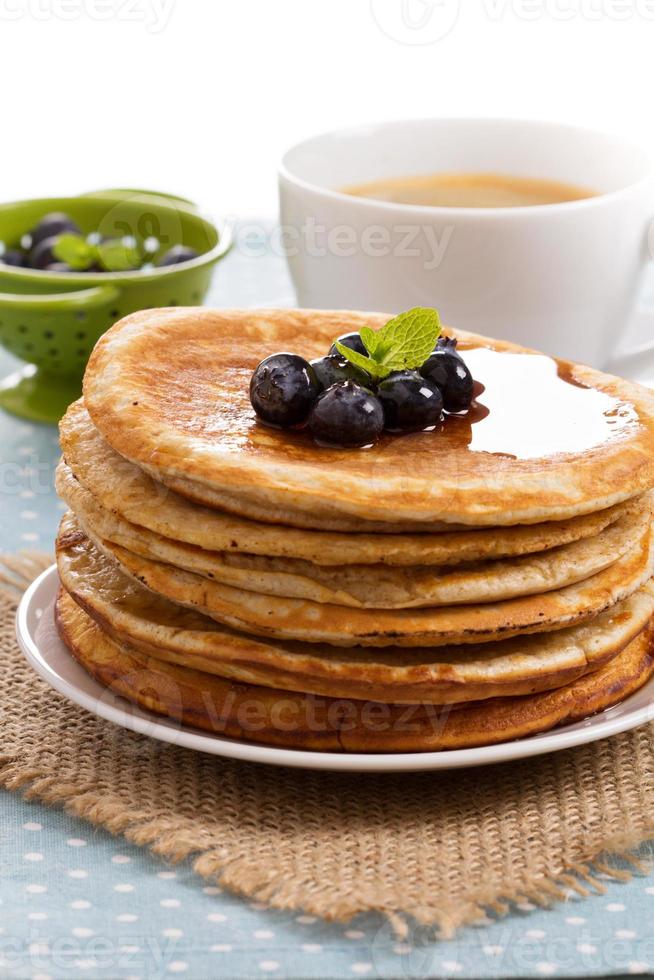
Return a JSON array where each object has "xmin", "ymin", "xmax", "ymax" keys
[{"xmin": 0, "ymin": 556, "xmax": 654, "ymax": 935}]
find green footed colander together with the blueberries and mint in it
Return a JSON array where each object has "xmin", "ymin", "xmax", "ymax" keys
[{"xmin": 0, "ymin": 189, "xmax": 231, "ymax": 422}]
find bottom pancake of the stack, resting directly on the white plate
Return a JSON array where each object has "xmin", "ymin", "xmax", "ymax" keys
[{"xmin": 56, "ymin": 590, "xmax": 654, "ymax": 752}]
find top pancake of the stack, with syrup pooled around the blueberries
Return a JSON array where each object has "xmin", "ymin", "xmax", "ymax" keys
[{"xmin": 84, "ymin": 308, "xmax": 654, "ymax": 527}]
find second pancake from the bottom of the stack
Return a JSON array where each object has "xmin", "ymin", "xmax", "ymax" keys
[{"xmin": 57, "ymin": 520, "xmax": 654, "ymax": 704}]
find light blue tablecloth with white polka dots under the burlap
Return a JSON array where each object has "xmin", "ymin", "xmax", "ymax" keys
[{"xmin": 0, "ymin": 231, "xmax": 654, "ymax": 980}]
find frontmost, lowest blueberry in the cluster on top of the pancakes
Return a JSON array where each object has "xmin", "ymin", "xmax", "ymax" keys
[{"xmin": 309, "ymin": 381, "xmax": 384, "ymax": 447}]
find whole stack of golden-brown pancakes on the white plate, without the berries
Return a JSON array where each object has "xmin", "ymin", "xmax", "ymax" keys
[{"xmin": 57, "ymin": 309, "xmax": 654, "ymax": 752}]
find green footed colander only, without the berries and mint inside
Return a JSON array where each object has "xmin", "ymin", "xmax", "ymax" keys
[{"xmin": 0, "ymin": 189, "xmax": 230, "ymax": 422}]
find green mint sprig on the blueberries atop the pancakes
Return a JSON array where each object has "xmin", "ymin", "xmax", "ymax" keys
[{"xmin": 334, "ymin": 306, "xmax": 441, "ymax": 378}]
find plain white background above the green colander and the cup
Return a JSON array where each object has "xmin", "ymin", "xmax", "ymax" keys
[{"xmin": 0, "ymin": 0, "xmax": 654, "ymax": 215}]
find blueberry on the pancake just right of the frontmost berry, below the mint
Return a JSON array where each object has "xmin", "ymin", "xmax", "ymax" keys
[{"xmin": 377, "ymin": 371, "xmax": 443, "ymax": 432}]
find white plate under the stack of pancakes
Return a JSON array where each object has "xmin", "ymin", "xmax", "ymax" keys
[{"xmin": 16, "ymin": 565, "xmax": 654, "ymax": 772}]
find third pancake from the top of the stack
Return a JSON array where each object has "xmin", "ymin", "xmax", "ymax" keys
[{"xmin": 56, "ymin": 464, "xmax": 652, "ymax": 609}]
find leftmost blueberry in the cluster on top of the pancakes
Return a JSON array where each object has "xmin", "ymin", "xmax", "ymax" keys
[{"xmin": 250, "ymin": 353, "xmax": 320, "ymax": 428}]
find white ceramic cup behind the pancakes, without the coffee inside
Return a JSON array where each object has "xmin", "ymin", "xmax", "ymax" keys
[{"xmin": 279, "ymin": 119, "xmax": 654, "ymax": 374}]
